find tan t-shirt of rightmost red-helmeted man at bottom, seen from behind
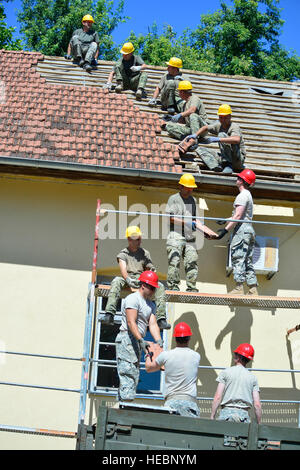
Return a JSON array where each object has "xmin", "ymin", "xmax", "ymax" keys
[{"xmin": 216, "ymin": 365, "xmax": 259, "ymax": 408}]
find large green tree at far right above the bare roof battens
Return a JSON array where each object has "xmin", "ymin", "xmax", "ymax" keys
[{"xmin": 189, "ymin": 0, "xmax": 300, "ymax": 80}]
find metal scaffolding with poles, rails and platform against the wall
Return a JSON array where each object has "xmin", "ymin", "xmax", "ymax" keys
[{"xmin": 0, "ymin": 199, "xmax": 300, "ymax": 446}]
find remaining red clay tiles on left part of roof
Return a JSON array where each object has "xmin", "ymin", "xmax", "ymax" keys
[{"xmin": 0, "ymin": 50, "xmax": 181, "ymax": 172}]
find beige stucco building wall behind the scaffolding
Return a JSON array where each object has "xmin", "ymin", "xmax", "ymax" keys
[{"xmin": 0, "ymin": 175, "xmax": 300, "ymax": 449}]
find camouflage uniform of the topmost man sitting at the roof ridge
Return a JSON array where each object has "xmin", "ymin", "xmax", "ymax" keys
[{"xmin": 70, "ymin": 29, "xmax": 99, "ymax": 63}]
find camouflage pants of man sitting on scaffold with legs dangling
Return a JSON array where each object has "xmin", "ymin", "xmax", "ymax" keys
[{"xmin": 105, "ymin": 275, "xmax": 167, "ymax": 320}]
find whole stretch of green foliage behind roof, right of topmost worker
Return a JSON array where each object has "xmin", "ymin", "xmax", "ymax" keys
[{"xmin": 128, "ymin": 0, "xmax": 300, "ymax": 80}]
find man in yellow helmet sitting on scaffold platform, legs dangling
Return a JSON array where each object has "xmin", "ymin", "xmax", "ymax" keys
[{"xmin": 102, "ymin": 226, "xmax": 171, "ymax": 330}]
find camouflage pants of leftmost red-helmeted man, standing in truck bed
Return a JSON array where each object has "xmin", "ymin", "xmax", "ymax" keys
[{"xmin": 116, "ymin": 332, "xmax": 141, "ymax": 401}]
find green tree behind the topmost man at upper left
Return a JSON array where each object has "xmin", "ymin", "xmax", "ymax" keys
[{"xmin": 18, "ymin": 0, "xmax": 127, "ymax": 60}]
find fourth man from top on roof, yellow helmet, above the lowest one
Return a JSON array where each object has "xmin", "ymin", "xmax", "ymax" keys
[{"xmin": 166, "ymin": 80, "xmax": 208, "ymax": 140}]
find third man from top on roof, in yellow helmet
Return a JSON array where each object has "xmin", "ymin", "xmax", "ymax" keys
[{"xmin": 148, "ymin": 57, "xmax": 188, "ymax": 114}]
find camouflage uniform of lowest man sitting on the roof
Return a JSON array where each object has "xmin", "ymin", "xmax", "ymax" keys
[{"xmin": 196, "ymin": 121, "xmax": 246, "ymax": 171}]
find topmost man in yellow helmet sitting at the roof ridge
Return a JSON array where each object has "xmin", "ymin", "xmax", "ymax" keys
[{"xmin": 65, "ymin": 15, "xmax": 99, "ymax": 72}]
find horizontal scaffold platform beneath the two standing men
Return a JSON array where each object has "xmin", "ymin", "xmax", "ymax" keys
[{"xmin": 95, "ymin": 284, "xmax": 300, "ymax": 309}]
